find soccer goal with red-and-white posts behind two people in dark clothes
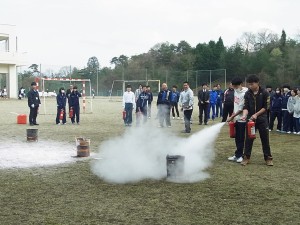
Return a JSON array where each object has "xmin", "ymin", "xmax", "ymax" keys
[{"xmin": 36, "ymin": 78, "xmax": 93, "ymax": 114}]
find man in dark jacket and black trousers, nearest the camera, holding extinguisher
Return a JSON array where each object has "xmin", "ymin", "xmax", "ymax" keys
[{"xmin": 241, "ymin": 75, "xmax": 273, "ymax": 166}]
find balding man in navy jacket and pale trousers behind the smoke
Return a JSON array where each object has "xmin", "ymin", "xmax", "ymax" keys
[{"xmin": 157, "ymin": 83, "xmax": 171, "ymax": 128}]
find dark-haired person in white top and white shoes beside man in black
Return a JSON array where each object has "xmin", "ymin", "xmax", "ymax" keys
[{"xmin": 227, "ymin": 77, "xmax": 248, "ymax": 163}]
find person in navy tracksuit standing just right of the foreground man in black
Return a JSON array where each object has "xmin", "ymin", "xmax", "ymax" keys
[{"xmin": 269, "ymin": 88, "xmax": 282, "ymax": 132}]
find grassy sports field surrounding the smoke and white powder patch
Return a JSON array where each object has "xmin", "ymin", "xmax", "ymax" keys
[{"xmin": 0, "ymin": 98, "xmax": 300, "ymax": 225}]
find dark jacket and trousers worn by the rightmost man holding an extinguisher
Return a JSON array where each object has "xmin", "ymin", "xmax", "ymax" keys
[{"xmin": 244, "ymin": 87, "xmax": 272, "ymax": 160}]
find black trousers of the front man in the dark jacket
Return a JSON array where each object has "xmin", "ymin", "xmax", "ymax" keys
[{"xmin": 245, "ymin": 118, "xmax": 272, "ymax": 160}]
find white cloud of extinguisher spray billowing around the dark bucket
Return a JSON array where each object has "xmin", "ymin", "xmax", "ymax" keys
[{"xmin": 91, "ymin": 123, "xmax": 224, "ymax": 183}]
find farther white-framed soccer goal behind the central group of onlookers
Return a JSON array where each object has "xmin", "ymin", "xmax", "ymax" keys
[{"xmin": 109, "ymin": 80, "xmax": 160, "ymax": 100}]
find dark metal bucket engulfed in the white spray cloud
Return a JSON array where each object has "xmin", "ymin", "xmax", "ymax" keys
[{"xmin": 166, "ymin": 155, "xmax": 184, "ymax": 178}]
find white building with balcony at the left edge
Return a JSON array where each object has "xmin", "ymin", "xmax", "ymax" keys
[{"xmin": 0, "ymin": 24, "xmax": 26, "ymax": 98}]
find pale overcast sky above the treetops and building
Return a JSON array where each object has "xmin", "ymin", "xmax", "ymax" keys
[{"xmin": 0, "ymin": 0, "xmax": 300, "ymax": 68}]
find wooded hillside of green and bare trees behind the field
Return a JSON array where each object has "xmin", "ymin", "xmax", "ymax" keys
[{"xmin": 19, "ymin": 29, "xmax": 300, "ymax": 92}]
